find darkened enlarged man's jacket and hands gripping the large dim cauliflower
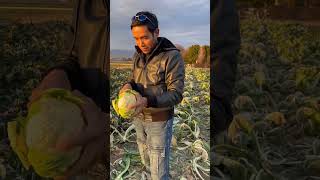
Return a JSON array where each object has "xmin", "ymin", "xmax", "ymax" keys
[{"xmin": 29, "ymin": 0, "xmax": 110, "ymax": 179}]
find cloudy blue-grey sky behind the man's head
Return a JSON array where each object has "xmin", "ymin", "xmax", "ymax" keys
[{"xmin": 110, "ymin": 0, "xmax": 210, "ymax": 50}]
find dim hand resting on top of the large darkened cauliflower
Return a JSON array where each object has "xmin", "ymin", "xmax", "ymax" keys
[{"xmin": 27, "ymin": 69, "xmax": 71, "ymax": 107}]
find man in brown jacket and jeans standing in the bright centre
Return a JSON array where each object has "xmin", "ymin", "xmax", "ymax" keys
[{"xmin": 120, "ymin": 11, "xmax": 185, "ymax": 180}]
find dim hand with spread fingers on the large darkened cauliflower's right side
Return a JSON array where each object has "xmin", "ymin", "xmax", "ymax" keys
[{"xmin": 56, "ymin": 90, "xmax": 108, "ymax": 179}]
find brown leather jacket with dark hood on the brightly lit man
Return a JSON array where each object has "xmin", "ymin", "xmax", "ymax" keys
[{"xmin": 130, "ymin": 37, "xmax": 185, "ymax": 119}]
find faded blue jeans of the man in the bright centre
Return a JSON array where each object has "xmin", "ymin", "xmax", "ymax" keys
[{"xmin": 133, "ymin": 118, "xmax": 173, "ymax": 180}]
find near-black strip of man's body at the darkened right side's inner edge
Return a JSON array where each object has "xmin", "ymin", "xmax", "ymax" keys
[{"xmin": 210, "ymin": 0, "xmax": 240, "ymax": 143}]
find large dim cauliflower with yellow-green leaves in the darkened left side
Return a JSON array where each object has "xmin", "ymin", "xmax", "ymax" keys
[{"xmin": 8, "ymin": 89, "xmax": 85, "ymax": 177}]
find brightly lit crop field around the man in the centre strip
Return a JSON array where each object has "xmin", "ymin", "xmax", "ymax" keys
[{"xmin": 110, "ymin": 63, "xmax": 210, "ymax": 179}]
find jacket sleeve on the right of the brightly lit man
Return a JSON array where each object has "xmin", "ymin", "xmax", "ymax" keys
[{"xmin": 147, "ymin": 51, "xmax": 185, "ymax": 108}]
